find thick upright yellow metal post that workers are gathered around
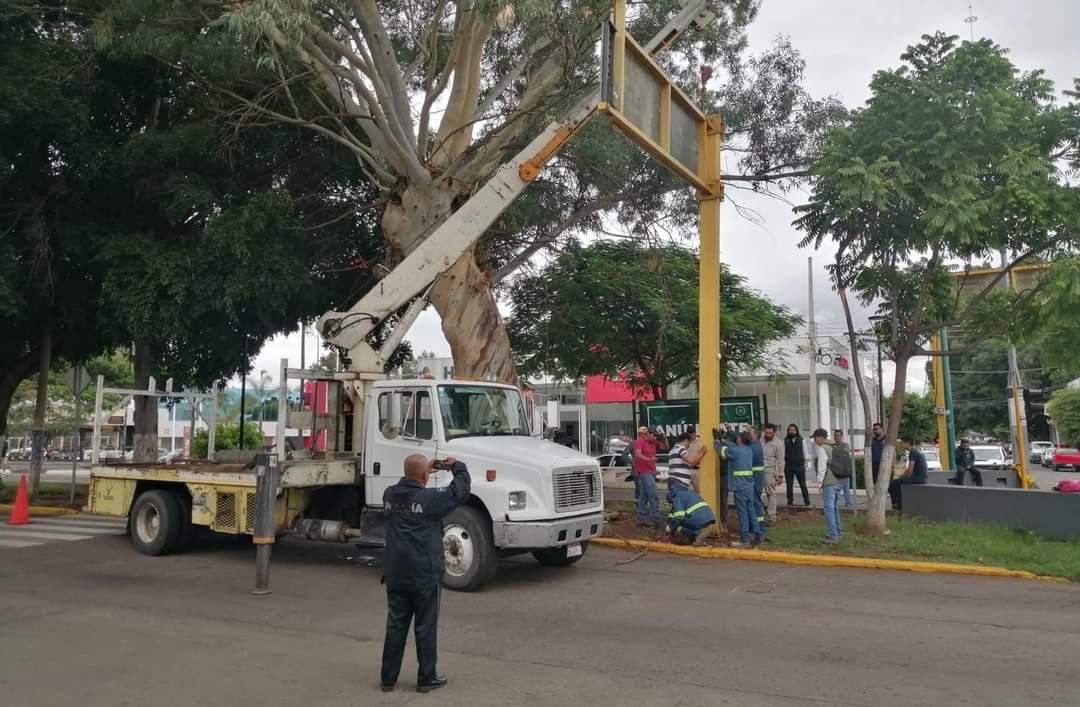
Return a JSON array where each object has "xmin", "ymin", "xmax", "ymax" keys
[{"xmin": 698, "ymin": 115, "xmax": 724, "ymax": 530}]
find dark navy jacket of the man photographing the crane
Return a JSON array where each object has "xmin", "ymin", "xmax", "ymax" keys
[{"xmin": 382, "ymin": 462, "xmax": 472, "ymax": 592}]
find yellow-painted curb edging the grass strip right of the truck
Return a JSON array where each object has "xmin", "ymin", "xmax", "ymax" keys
[{"xmin": 591, "ymin": 538, "xmax": 1068, "ymax": 582}]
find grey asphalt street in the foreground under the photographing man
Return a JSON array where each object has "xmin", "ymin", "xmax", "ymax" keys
[{"xmin": 0, "ymin": 522, "xmax": 1080, "ymax": 707}]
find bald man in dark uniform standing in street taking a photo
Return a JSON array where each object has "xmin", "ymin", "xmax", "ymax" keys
[{"xmin": 381, "ymin": 454, "xmax": 471, "ymax": 692}]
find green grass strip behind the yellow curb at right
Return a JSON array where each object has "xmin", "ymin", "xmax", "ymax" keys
[{"xmin": 766, "ymin": 513, "xmax": 1080, "ymax": 582}]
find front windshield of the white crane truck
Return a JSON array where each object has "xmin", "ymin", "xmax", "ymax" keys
[{"xmin": 438, "ymin": 385, "xmax": 529, "ymax": 440}]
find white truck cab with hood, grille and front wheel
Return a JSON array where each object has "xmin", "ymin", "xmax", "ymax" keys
[{"xmin": 362, "ymin": 379, "xmax": 604, "ymax": 590}]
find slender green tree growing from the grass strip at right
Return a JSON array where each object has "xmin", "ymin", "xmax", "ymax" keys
[{"xmin": 796, "ymin": 33, "xmax": 1078, "ymax": 532}]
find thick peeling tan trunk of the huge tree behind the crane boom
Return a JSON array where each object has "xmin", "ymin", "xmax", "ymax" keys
[{"xmin": 382, "ymin": 181, "xmax": 517, "ymax": 383}]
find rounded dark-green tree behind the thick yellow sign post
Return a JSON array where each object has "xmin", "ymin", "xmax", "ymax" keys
[{"xmin": 508, "ymin": 241, "xmax": 800, "ymax": 398}]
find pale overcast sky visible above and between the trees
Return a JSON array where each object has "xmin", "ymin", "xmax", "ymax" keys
[{"xmin": 247, "ymin": 0, "xmax": 1080, "ymax": 392}]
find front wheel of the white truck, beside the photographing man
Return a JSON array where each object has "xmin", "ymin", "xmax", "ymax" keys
[{"xmin": 443, "ymin": 506, "xmax": 499, "ymax": 592}]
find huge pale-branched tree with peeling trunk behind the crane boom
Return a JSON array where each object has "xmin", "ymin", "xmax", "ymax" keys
[{"xmin": 109, "ymin": 0, "xmax": 842, "ymax": 380}]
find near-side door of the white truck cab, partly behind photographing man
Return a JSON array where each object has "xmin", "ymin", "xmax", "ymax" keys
[{"xmin": 364, "ymin": 389, "xmax": 438, "ymax": 505}]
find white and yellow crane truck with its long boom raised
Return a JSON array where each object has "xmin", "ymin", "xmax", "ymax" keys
[{"xmin": 87, "ymin": 0, "xmax": 713, "ymax": 592}]
